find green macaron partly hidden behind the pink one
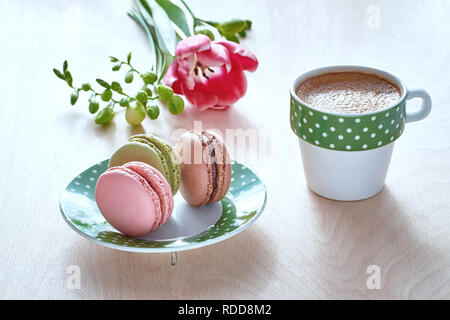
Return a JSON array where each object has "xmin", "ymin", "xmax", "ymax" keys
[{"xmin": 109, "ymin": 134, "xmax": 181, "ymax": 195}]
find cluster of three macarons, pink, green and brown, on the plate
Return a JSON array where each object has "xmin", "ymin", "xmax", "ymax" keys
[{"xmin": 95, "ymin": 130, "xmax": 231, "ymax": 237}]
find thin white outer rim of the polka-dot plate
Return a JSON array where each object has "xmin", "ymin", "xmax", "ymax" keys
[{"xmin": 59, "ymin": 159, "xmax": 267, "ymax": 253}]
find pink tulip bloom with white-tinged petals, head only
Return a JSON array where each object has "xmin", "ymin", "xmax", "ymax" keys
[{"xmin": 164, "ymin": 34, "xmax": 258, "ymax": 110}]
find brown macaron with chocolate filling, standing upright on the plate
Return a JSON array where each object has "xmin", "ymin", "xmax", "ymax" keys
[{"xmin": 176, "ymin": 130, "xmax": 231, "ymax": 206}]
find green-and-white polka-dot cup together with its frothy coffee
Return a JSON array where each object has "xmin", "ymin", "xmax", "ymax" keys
[{"xmin": 290, "ymin": 66, "xmax": 431, "ymax": 201}]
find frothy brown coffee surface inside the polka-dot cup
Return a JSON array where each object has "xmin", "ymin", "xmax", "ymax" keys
[{"xmin": 296, "ymin": 72, "xmax": 401, "ymax": 114}]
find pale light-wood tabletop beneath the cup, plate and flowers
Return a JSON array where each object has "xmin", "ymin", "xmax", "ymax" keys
[{"xmin": 0, "ymin": 0, "xmax": 450, "ymax": 299}]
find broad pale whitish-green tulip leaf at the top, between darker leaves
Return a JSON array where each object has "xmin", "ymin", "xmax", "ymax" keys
[{"xmin": 145, "ymin": 0, "xmax": 177, "ymax": 56}]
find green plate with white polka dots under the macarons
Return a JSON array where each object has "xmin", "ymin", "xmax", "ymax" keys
[{"xmin": 59, "ymin": 160, "xmax": 267, "ymax": 252}]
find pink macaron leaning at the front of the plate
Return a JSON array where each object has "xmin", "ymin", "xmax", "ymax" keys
[{"xmin": 95, "ymin": 161, "xmax": 173, "ymax": 237}]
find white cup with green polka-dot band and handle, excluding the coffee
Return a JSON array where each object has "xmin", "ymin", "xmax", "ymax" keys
[{"xmin": 290, "ymin": 66, "xmax": 431, "ymax": 201}]
